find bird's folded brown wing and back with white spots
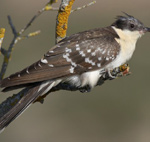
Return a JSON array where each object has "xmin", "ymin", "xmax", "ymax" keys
[{"xmin": 1, "ymin": 27, "xmax": 120, "ymax": 87}]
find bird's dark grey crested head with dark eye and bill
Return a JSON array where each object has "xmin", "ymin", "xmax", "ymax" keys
[{"xmin": 112, "ymin": 13, "xmax": 150, "ymax": 39}]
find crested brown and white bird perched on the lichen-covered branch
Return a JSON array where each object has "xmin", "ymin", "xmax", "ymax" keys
[{"xmin": 0, "ymin": 13, "xmax": 150, "ymax": 130}]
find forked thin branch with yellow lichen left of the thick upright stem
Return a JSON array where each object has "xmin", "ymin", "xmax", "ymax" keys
[{"xmin": 0, "ymin": 0, "xmax": 57, "ymax": 80}]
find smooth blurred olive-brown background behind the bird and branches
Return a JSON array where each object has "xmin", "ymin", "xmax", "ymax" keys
[{"xmin": 0, "ymin": 0, "xmax": 150, "ymax": 142}]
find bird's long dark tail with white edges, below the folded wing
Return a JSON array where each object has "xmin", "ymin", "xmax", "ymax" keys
[{"xmin": 0, "ymin": 81, "xmax": 55, "ymax": 133}]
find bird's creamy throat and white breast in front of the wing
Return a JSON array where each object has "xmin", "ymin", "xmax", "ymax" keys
[{"xmin": 106, "ymin": 27, "xmax": 141, "ymax": 69}]
